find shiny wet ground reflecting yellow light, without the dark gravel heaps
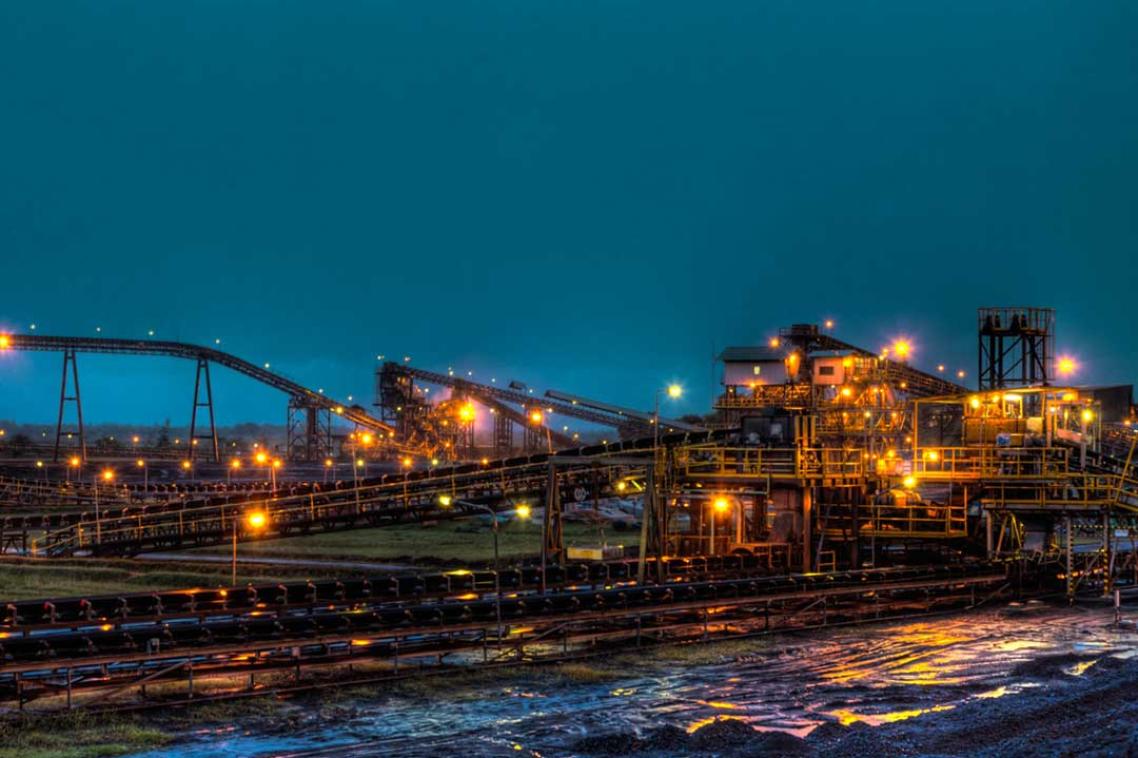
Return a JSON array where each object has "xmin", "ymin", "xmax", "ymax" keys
[{"xmin": 135, "ymin": 605, "xmax": 1138, "ymax": 758}]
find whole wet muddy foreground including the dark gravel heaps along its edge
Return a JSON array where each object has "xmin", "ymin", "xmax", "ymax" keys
[{"xmin": 135, "ymin": 604, "xmax": 1138, "ymax": 758}]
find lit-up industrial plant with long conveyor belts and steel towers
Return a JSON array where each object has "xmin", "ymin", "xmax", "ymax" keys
[{"xmin": 0, "ymin": 307, "xmax": 1138, "ymax": 712}]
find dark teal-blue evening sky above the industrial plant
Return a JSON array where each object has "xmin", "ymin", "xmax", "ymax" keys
[{"xmin": 0, "ymin": 0, "xmax": 1138, "ymax": 423}]
